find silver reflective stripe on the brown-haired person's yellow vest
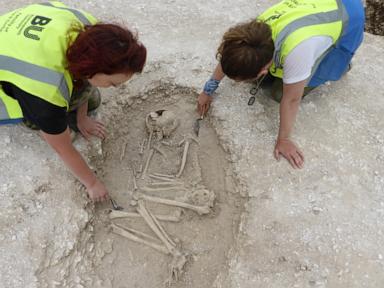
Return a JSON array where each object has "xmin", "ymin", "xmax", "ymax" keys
[{"xmin": 273, "ymin": 0, "xmax": 348, "ymax": 69}]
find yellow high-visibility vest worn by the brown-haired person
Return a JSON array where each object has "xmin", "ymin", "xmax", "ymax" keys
[{"xmin": 258, "ymin": 0, "xmax": 348, "ymax": 78}]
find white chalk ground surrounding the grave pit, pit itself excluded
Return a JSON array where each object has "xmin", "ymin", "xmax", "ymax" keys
[{"xmin": 0, "ymin": 0, "xmax": 384, "ymax": 288}]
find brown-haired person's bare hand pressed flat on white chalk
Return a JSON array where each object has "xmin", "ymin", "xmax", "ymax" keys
[{"xmin": 274, "ymin": 139, "xmax": 304, "ymax": 169}]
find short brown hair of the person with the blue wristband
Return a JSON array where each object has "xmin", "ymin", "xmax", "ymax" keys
[{"xmin": 216, "ymin": 20, "xmax": 274, "ymax": 80}]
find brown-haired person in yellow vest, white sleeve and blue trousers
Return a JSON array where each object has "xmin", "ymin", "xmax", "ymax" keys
[{"xmin": 197, "ymin": 0, "xmax": 364, "ymax": 168}]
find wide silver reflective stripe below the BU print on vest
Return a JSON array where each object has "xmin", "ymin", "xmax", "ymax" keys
[{"xmin": 0, "ymin": 55, "xmax": 71, "ymax": 103}]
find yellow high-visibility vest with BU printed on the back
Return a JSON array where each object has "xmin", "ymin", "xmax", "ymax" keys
[{"xmin": 0, "ymin": 1, "xmax": 97, "ymax": 121}]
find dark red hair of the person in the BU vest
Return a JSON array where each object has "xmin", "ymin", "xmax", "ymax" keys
[{"xmin": 66, "ymin": 24, "xmax": 147, "ymax": 80}]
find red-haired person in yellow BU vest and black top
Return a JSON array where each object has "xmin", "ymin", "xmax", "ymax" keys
[{"xmin": 0, "ymin": 2, "xmax": 146, "ymax": 202}]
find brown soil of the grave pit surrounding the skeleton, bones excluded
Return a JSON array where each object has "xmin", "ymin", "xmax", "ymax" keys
[{"xmin": 91, "ymin": 85, "xmax": 244, "ymax": 288}]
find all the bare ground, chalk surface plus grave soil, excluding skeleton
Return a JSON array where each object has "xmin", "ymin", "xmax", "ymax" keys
[{"xmin": 0, "ymin": 0, "xmax": 384, "ymax": 288}]
